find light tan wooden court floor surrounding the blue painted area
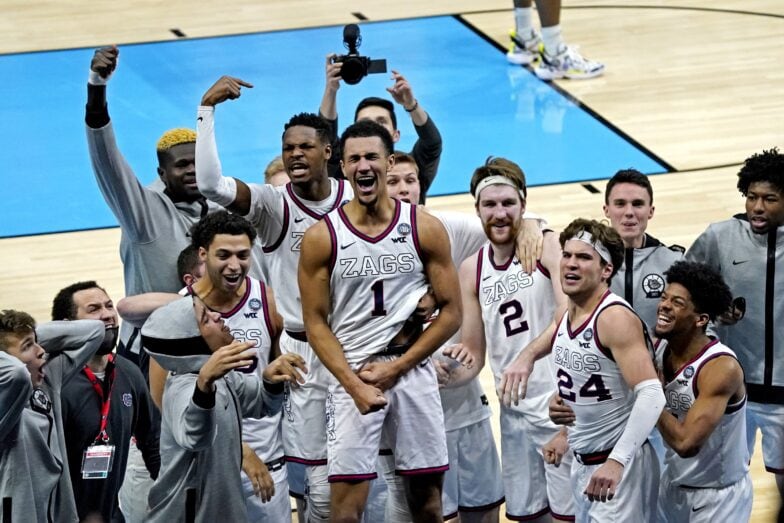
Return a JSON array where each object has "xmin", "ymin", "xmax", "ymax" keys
[{"xmin": 0, "ymin": 0, "xmax": 784, "ymax": 522}]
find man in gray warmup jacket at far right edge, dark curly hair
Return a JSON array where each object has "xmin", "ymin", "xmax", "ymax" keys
[{"xmin": 686, "ymin": 148, "xmax": 784, "ymax": 497}]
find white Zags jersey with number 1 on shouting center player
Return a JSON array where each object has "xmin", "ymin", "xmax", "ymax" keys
[{"xmin": 325, "ymin": 201, "xmax": 427, "ymax": 365}]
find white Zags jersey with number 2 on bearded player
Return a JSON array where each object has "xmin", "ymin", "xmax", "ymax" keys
[{"xmin": 476, "ymin": 243, "xmax": 555, "ymax": 411}]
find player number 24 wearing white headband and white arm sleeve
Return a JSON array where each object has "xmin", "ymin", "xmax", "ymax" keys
[{"xmin": 499, "ymin": 219, "xmax": 664, "ymax": 521}]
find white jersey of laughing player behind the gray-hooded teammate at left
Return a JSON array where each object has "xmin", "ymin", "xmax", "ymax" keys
[{"xmin": 185, "ymin": 276, "xmax": 283, "ymax": 463}]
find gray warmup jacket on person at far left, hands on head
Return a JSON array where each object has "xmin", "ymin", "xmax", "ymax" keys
[{"xmin": 0, "ymin": 320, "xmax": 104, "ymax": 523}]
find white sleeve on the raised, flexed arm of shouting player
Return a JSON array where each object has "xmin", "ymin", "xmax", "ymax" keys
[{"xmin": 196, "ymin": 106, "xmax": 237, "ymax": 207}]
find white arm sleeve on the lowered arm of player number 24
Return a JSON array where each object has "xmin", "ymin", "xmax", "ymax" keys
[{"xmin": 609, "ymin": 379, "xmax": 665, "ymax": 467}]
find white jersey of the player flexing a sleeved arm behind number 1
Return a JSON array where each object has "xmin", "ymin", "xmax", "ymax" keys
[{"xmin": 246, "ymin": 178, "xmax": 353, "ymax": 332}]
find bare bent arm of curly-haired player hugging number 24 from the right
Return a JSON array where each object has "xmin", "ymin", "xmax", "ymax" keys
[{"xmin": 657, "ymin": 356, "xmax": 745, "ymax": 458}]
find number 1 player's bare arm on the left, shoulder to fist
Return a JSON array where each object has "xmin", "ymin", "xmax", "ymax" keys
[{"xmin": 297, "ymin": 221, "xmax": 387, "ymax": 414}]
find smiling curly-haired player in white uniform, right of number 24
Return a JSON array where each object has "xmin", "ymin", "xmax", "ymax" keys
[{"xmin": 656, "ymin": 262, "xmax": 752, "ymax": 522}]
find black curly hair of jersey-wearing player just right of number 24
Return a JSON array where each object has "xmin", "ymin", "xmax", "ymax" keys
[{"xmin": 664, "ymin": 261, "xmax": 732, "ymax": 321}]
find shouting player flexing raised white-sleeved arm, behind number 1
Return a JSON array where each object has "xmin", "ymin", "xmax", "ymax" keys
[{"xmin": 196, "ymin": 76, "xmax": 352, "ymax": 521}]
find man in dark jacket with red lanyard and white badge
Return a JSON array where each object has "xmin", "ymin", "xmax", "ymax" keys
[{"xmin": 52, "ymin": 281, "xmax": 160, "ymax": 521}]
